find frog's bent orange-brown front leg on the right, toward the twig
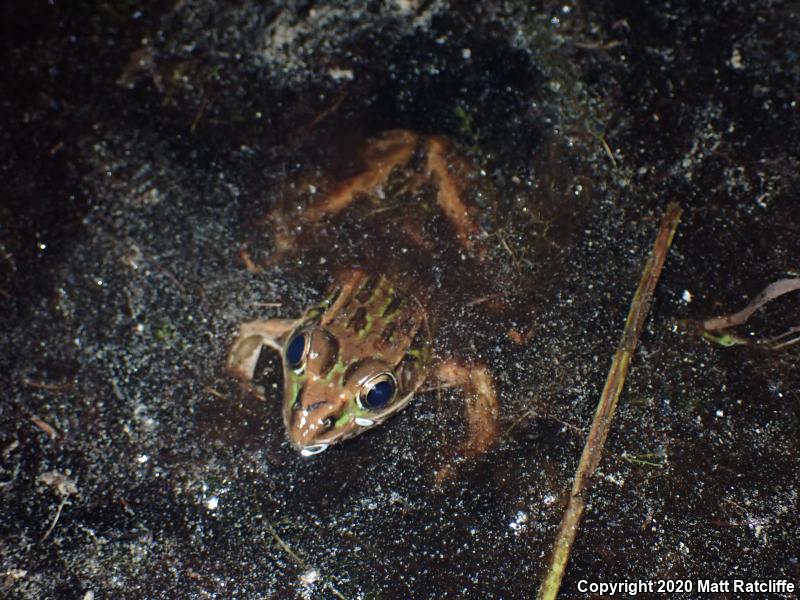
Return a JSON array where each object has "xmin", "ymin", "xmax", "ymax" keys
[{"xmin": 436, "ymin": 362, "xmax": 500, "ymax": 484}]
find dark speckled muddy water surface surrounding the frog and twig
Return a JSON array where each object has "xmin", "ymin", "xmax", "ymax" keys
[{"xmin": 0, "ymin": 1, "xmax": 800, "ymax": 599}]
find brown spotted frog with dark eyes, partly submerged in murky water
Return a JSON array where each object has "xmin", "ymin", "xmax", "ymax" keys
[{"xmin": 227, "ymin": 129, "xmax": 500, "ymax": 473}]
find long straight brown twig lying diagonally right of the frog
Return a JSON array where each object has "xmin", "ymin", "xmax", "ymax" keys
[{"xmin": 537, "ymin": 203, "xmax": 681, "ymax": 600}]
